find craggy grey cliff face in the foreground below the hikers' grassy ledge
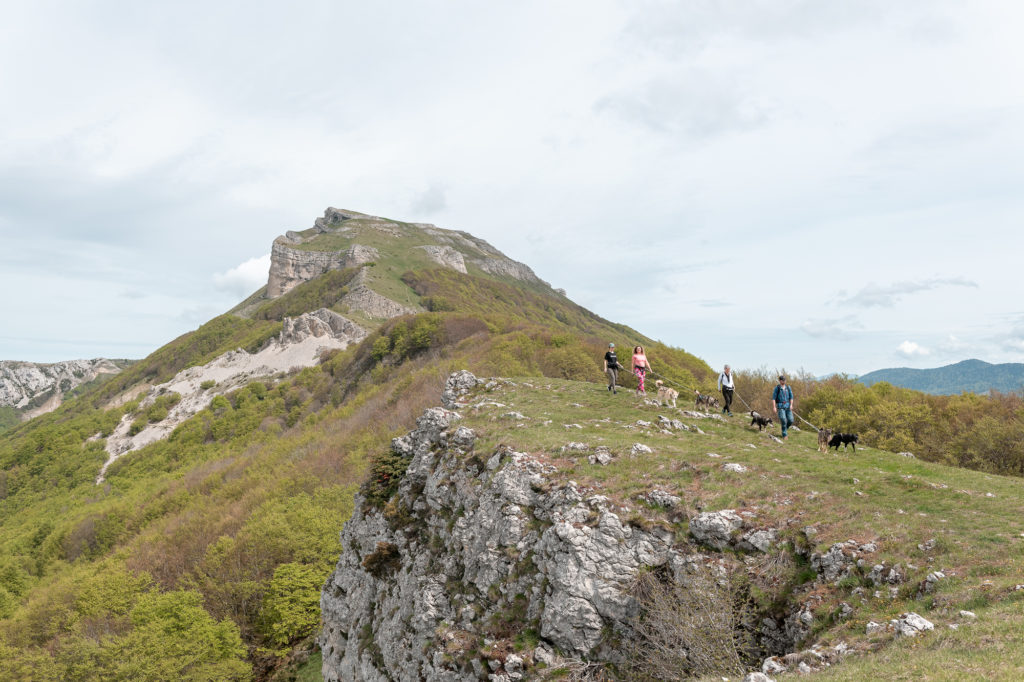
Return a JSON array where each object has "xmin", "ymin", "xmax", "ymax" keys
[{"xmin": 321, "ymin": 372, "xmax": 794, "ymax": 682}]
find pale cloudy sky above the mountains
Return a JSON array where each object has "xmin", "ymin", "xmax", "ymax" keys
[{"xmin": 0, "ymin": 0, "xmax": 1024, "ymax": 375}]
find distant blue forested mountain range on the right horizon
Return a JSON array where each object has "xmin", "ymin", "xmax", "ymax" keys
[{"xmin": 857, "ymin": 359, "xmax": 1024, "ymax": 395}]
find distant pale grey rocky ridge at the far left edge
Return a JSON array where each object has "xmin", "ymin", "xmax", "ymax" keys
[{"xmin": 0, "ymin": 358, "xmax": 121, "ymax": 414}]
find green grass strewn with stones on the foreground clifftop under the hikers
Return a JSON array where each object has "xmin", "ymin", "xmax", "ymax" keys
[{"xmin": 452, "ymin": 378, "xmax": 1024, "ymax": 680}]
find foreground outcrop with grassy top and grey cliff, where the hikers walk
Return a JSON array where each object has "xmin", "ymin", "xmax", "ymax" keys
[{"xmin": 322, "ymin": 373, "xmax": 1024, "ymax": 682}]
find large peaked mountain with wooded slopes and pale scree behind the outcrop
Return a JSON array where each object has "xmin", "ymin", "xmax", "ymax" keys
[{"xmin": 0, "ymin": 211, "xmax": 713, "ymax": 680}]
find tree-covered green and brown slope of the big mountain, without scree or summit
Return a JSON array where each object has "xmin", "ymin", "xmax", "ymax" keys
[{"xmin": 0, "ymin": 259, "xmax": 712, "ymax": 680}]
